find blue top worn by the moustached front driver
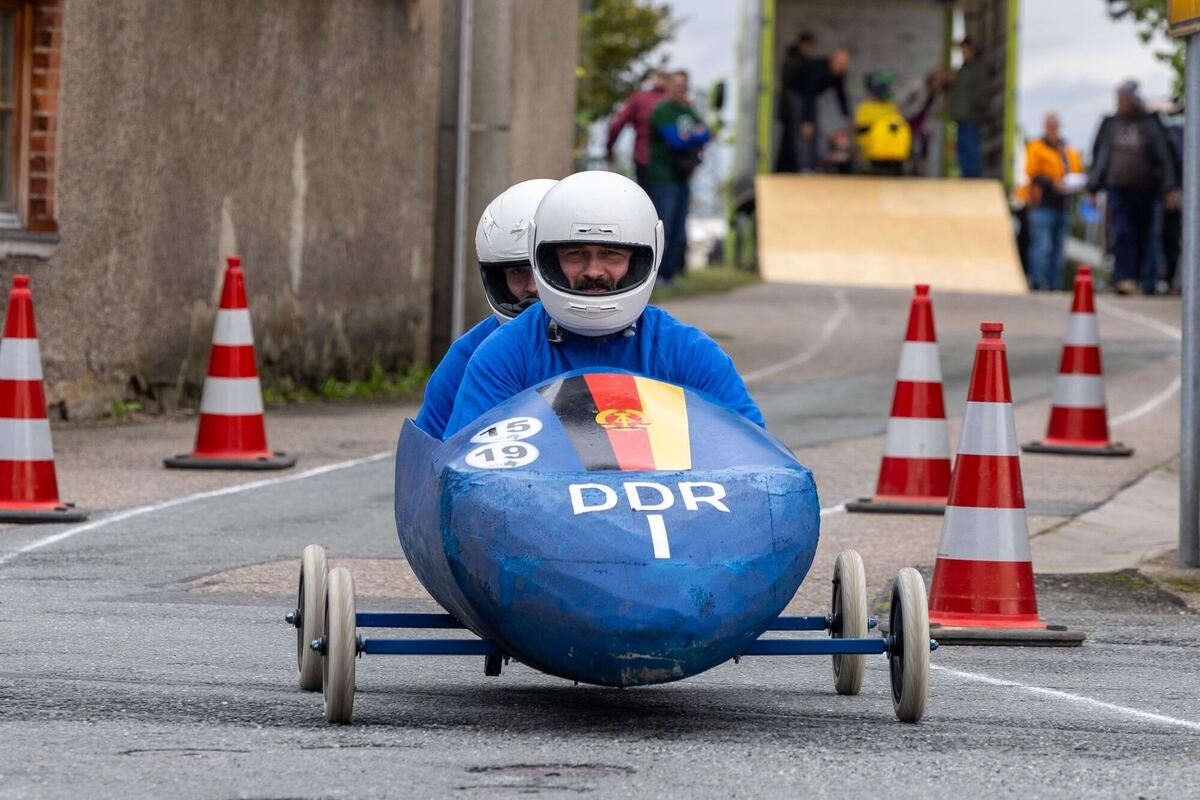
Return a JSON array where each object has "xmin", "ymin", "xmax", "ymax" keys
[{"xmin": 443, "ymin": 303, "xmax": 767, "ymax": 439}]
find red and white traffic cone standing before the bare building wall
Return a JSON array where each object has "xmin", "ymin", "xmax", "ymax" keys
[{"xmin": 163, "ymin": 255, "xmax": 296, "ymax": 469}]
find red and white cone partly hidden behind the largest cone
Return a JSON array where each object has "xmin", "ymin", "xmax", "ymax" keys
[{"xmin": 846, "ymin": 283, "xmax": 950, "ymax": 513}]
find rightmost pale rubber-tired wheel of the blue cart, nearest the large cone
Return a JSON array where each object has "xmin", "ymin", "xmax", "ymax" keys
[{"xmin": 888, "ymin": 566, "xmax": 929, "ymax": 722}]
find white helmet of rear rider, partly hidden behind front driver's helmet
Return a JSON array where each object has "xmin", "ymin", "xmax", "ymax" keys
[{"xmin": 475, "ymin": 178, "xmax": 558, "ymax": 325}]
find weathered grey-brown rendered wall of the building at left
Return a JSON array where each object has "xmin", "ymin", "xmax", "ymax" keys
[{"xmin": 0, "ymin": 0, "xmax": 577, "ymax": 416}]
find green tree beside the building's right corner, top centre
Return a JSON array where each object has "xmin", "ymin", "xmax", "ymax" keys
[{"xmin": 575, "ymin": 0, "xmax": 677, "ymax": 128}]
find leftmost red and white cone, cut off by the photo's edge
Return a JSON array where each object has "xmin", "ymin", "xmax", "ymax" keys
[{"xmin": 0, "ymin": 275, "xmax": 88, "ymax": 522}]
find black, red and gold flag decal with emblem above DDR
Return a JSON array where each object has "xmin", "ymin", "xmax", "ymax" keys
[{"xmin": 539, "ymin": 373, "xmax": 691, "ymax": 471}]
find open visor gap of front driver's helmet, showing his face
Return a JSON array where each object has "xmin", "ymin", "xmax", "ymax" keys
[{"xmin": 536, "ymin": 240, "xmax": 654, "ymax": 296}]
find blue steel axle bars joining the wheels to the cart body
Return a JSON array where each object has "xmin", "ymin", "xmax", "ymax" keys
[{"xmin": 354, "ymin": 612, "xmax": 890, "ymax": 656}]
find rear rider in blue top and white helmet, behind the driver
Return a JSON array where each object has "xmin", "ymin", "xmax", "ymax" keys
[{"xmin": 414, "ymin": 179, "xmax": 558, "ymax": 439}]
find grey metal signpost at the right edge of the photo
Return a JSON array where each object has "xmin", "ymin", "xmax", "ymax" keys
[{"xmin": 1180, "ymin": 34, "xmax": 1200, "ymax": 567}]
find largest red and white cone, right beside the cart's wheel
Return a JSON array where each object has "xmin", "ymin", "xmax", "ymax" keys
[{"xmin": 929, "ymin": 323, "xmax": 1084, "ymax": 645}]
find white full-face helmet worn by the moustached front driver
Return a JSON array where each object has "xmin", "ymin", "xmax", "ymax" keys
[{"xmin": 529, "ymin": 172, "xmax": 662, "ymax": 336}]
